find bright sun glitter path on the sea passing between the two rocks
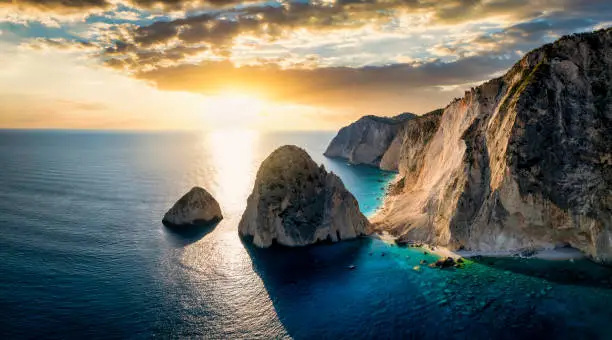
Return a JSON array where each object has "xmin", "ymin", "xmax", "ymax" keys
[{"xmin": 180, "ymin": 129, "xmax": 287, "ymax": 338}]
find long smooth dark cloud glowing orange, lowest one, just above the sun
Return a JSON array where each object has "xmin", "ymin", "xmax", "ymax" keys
[{"xmin": 136, "ymin": 56, "xmax": 514, "ymax": 106}]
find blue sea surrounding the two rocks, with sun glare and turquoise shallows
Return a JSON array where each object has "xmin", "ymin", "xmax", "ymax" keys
[{"xmin": 0, "ymin": 131, "xmax": 612, "ymax": 339}]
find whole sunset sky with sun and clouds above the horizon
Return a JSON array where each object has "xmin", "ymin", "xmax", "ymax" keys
[{"xmin": 0, "ymin": 0, "xmax": 612, "ymax": 130}]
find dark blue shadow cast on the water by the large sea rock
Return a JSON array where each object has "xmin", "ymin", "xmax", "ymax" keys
[{"xmin": 242, "ymin": 238, "xmax": 372, "ymax": 339}]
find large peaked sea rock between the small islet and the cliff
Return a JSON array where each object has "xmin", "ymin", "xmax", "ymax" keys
[{"xmin": 238, "ymin": 145, "xmax": 369, "ymax": 247}]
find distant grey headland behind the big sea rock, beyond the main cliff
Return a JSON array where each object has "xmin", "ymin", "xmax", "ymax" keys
[{"xmin": 325, "ymin": 113, "xmax": 416, "ymax": 170}]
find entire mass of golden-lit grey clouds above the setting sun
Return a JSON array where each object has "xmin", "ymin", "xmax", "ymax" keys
[{"xmin": 0, "ymin": 0, "xmax": 612, "ymax": 121}]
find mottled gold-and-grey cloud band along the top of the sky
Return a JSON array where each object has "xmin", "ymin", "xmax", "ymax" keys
[{"xmin": 99, "ymin": 0, "xmax": 609, "ymax": 71}]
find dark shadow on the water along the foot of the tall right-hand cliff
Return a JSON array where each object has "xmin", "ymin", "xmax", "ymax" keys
[{"xmin": 470, "ymin": 256, "xmax": 612, "ymax": 289}]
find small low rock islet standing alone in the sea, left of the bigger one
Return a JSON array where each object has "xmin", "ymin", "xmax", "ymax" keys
[{"xmin": 162, "ymin": 187, "xmax": 223, "ymax": 226}]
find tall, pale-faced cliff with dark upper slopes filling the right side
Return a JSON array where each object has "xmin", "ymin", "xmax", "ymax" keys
[{"xmin": 375, "ymin": 29, "xmax": 612, "ymax": 263}]
